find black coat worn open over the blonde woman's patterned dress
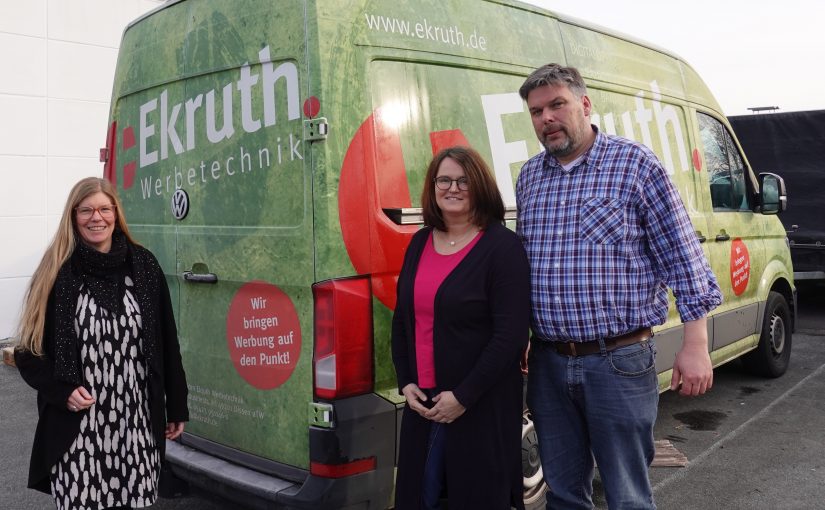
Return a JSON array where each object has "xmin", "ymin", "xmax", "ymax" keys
[{"xmin": 14, "ymin": 246, "xmax": 189, "ymax": 493}]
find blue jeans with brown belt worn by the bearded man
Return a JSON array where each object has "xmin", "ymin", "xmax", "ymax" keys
[{"xmin": 527, "ymin": 339, "xmax": 659, "ymax": 510}]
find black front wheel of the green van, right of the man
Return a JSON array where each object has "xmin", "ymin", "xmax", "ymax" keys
[{"xmin": 742, "ymin": 291, "xmax": 792, "ymax": 377}]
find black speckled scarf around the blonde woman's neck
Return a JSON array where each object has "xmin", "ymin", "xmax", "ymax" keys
[{"xmin": 53, "ymin": 230, "xmax": 159, "ymax": 385}]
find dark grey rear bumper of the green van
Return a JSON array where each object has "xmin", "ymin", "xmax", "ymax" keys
[{"xmin": 166, "ymin": 394, "xmax": 396, "ymax": 510}]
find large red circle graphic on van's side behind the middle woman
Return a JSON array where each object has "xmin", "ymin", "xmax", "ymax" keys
[{"xmin": 338, "ymin": 108, "xmax": 470, "ymax": 310}]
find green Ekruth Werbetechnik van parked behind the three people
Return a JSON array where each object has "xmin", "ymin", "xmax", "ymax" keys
[{"xmin": 101, "ymin": 0, "xmax": 795, "ymax": 509}]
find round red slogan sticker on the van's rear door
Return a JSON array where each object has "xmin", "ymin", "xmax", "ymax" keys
[{"xmin": 226, "ymin": 281, "xmax": 301, "ymax": 390}]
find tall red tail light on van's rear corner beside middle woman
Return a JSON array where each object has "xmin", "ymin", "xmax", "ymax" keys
[{"xmin": 312, "ymin": 277, "xmax": 375, "ymax": 400}]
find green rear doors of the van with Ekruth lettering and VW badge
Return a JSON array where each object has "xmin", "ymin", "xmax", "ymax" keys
[{"xmin": 110, "ymin": 0, "xmax": 314, "ymax": 474}]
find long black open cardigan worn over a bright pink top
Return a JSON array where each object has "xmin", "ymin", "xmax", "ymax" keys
[{"xmin": 392, "ymin": 224, "xmax": 530, "ymax": 510}]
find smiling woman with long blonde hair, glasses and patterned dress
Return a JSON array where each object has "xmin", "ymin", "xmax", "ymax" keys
[{"xmin": 15, "ymin": 177, "xmax": 188, "ymax": 509}]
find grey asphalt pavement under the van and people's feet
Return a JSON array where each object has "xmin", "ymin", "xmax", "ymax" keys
[{"xmin": 0, "ymin": 288, "xmax": 825, "ymax": 510}]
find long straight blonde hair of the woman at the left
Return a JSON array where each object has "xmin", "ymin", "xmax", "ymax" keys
[{"xmin": 17, "ymin": 177, "xmax": 134, "ymax": 356}]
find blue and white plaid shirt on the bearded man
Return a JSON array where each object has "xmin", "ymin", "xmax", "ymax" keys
[{"xmin": 516, "ymin": 127, "xmax": 722, "ymax": 341}]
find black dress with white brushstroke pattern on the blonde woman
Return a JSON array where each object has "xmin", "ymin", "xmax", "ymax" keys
[{"xmin": 51, "ymin": 276, "xmax": 160, "ymax": 510}]
